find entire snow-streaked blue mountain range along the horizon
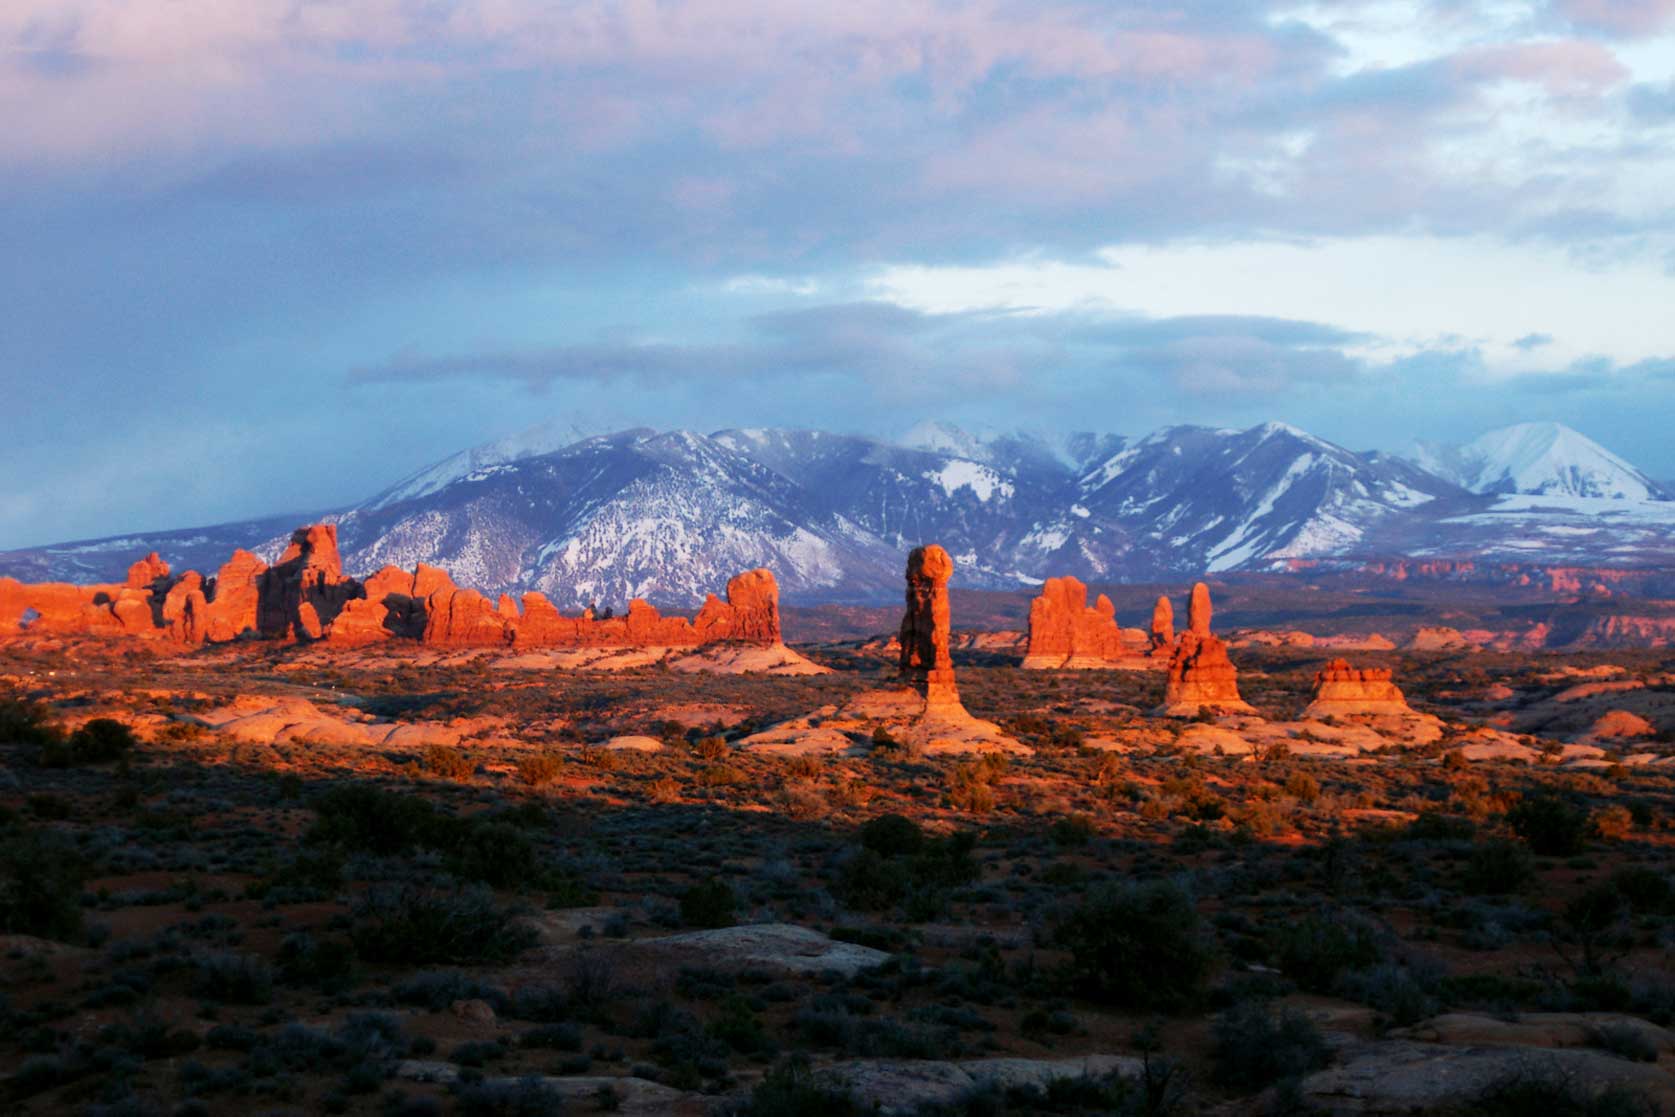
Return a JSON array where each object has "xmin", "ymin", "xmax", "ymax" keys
[{"xmin": 0, "ymin": 422, "xmax": 1675, "ymax": 608}]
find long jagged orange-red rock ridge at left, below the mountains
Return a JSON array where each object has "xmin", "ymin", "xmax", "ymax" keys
[{"xmin": 0, "ymin": 524, "xmax": 782, "ymax": 648}]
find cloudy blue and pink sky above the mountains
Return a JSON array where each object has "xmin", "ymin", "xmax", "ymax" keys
[{"xmin": 0, "ymin": 0, "xmax": 1675, "ymax": 548}]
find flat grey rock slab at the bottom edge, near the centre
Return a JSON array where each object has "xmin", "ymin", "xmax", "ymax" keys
[{"xmin": 816, "ymin": 1055, "xmax": 1142, "ymax": 1115}]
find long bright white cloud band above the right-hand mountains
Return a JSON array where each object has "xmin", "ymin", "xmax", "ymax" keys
[{"xmin": 871, "ymin": 236, "xmax": 1675, "ymax": 373}]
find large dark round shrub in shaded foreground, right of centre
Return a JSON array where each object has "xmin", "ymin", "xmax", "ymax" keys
[{"xmin": 1054, "ymin": 881, "xmax": 1214, "ymax": 1011}]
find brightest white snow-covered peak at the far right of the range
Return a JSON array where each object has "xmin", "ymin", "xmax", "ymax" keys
[{"xmin": 1414, "ymin": 422, "xmax": 1665, "ymax": 501}]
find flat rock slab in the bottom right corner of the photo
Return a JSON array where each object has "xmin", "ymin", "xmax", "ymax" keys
[{"xmin": 1301, "ymin": 1040, "xmax": 1675, "ymax": 1117}]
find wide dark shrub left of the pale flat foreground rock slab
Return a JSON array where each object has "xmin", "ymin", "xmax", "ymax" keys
[{"xmin": 348, "ymin": 879, "xmax": 534, "ymax": 965}]
